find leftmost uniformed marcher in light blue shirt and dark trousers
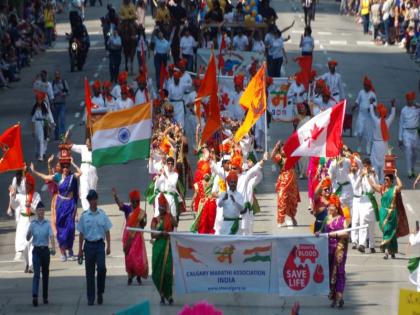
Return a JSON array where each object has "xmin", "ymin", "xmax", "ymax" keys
[{"xmin": 26, "ymin": 201, "xmax": 55, "ymax": 306}]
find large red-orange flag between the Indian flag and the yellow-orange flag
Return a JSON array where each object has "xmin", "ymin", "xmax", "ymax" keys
[{"xmin": 196, "ymin": 53, "xmax": 221, "ymax": 144}]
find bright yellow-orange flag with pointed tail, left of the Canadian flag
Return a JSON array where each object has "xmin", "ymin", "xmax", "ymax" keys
[{"xmin": 234, "ymin": 64, "xmax": 267, "ymax": 142}]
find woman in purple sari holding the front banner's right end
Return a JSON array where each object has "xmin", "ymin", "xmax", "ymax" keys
[{"xmin": 316, "ymin": 195, "xmax": 349, "ymax": 308}]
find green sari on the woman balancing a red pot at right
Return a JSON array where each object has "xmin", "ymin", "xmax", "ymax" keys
[{"xmin": 379, "ymin": 185, "xmax": 398, "ymax": 254}]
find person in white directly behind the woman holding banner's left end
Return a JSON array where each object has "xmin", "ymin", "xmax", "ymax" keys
[{"xmin": 154, "ymin": 157, "xmax": 179, "ymax": 218}]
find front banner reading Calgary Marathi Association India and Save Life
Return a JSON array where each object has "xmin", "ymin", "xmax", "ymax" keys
[{"xmin": 171, "ymin": 234, "xmax": 329, "ymax": 296}]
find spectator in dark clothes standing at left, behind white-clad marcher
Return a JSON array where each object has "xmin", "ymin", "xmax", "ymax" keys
[{"xmin": 52, "ymin": 70, "xmax": 69, "ymax": 140}]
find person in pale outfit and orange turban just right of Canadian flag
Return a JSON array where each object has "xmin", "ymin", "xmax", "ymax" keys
[{"xmin": 352, "ymin": 76, "xmax": 376, "ymax": 155}]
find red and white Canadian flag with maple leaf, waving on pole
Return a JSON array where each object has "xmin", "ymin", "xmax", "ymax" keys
[{"xmin": 283, "ymin": 100, "xmax": 346, "ymax": 170}]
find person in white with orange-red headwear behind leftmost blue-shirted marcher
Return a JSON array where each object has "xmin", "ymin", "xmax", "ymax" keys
[{"xmin": 10, "ymin": 173, "xmax": 41, "ymax": 273}]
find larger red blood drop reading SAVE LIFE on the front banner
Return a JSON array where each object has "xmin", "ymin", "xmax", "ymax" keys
[{"xmin": 283, "ymin": 246, "xmax": 311, "ymax": 291}]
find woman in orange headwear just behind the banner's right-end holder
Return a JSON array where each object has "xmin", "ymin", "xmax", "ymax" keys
[{"xmin": 311, "ymin": 177, "xmax": 332, "ymax": 232}]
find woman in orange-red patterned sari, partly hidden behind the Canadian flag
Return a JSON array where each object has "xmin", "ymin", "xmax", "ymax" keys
[{"xmin": 271, "ymin": 141, "xmax": 300, "ymax": 227}]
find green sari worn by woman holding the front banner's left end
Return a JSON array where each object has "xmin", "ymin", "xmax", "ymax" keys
[{"xmin": 152, "ymin": 215, "xmax": 173, "ymax": 299}]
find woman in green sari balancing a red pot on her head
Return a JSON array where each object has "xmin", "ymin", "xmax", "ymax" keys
[{"xmin": 368, "ymin": 172, "xmax": 402, "ymax": 259}]
